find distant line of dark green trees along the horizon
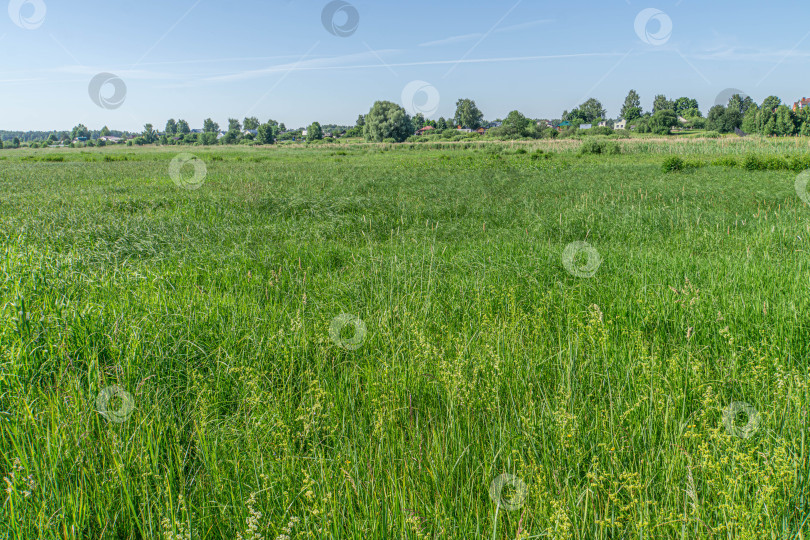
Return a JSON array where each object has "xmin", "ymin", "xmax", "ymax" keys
[{"xmin": 0, "ymin": 90, "xmax": 810, "ymax": 148}]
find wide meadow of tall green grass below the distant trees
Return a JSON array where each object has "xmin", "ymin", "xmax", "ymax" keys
[{"xmin": 0, "ymin": 138, "xmax": 810, "ymax": 540}]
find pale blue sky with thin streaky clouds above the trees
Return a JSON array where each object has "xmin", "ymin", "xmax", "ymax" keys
[{"xmin": 0, "ymin": 0, "xmax": 810, "ymax": 131}]
